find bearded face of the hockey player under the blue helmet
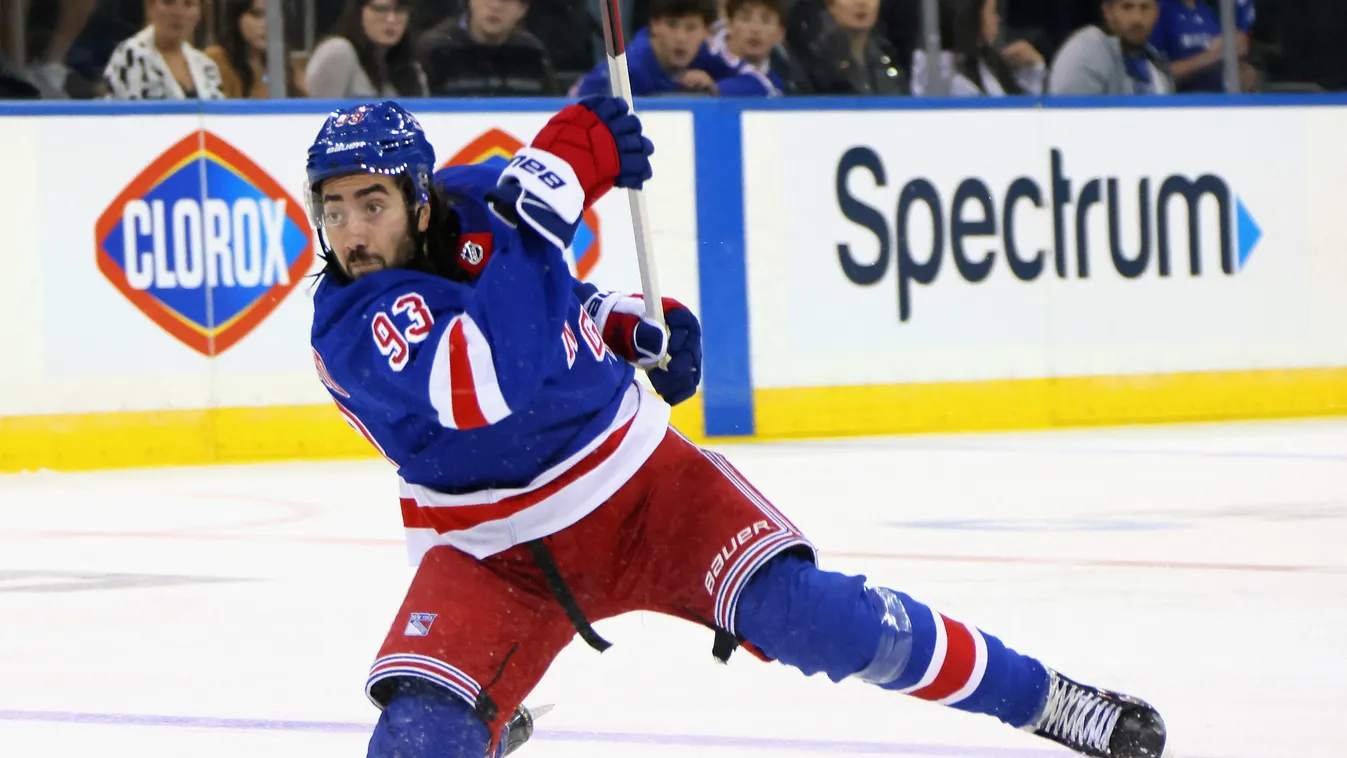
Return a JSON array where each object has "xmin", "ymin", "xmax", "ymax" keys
[{"xmin": 322, "ymin": 174, "xmax": 430, "ymax": 279}]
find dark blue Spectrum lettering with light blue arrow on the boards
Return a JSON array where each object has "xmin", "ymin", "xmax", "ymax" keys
[{"xmin": 835, "ymin": 147, "xmax": 1263, "ymax": 322}]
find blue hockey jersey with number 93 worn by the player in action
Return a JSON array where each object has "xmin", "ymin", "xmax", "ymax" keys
[{"xmin": 311, "ymin": 167, "xmax": 669, "ymax": 563}]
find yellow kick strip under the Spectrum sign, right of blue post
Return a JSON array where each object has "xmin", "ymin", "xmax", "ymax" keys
[{"xmin": 753, "ymin": 368, "xmax": 1347, "ymax": 439}]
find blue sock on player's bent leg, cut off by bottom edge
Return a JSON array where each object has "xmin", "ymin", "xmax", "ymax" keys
[{"xmin": 366, "ymin": 679, "xmax": 490, "ymax": 758}]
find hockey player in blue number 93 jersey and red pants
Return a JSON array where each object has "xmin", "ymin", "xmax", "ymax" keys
[{"xmin": 308, "ymin": 97, "xmax": 1165, "ymax": 758}]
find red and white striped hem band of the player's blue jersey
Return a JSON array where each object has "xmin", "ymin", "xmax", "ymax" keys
[{"xmin": 400, "ymin": 382, "xmax": 669, "ymax": 564}]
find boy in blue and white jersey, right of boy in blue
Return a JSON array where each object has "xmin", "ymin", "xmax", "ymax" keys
[{"xmin": 699, "ymin": 0, "xmax": 785, "ymax": 96}]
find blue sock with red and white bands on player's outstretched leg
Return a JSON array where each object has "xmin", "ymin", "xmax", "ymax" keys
[{"xmin": 735, "ymin": 555, "xmax": 1048, "ymax": 727}]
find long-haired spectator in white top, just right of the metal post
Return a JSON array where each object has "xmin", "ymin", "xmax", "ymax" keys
[{"xmin": 912, "ymin": 0, "xmax": 1048, "ymax": 97}]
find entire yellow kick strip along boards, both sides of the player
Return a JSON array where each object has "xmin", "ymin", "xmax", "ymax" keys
[{"xmin": 0, "ymin": 368, "xmax": 1347, "ymax": 473}]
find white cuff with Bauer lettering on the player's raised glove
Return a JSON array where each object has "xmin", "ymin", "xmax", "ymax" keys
[{"xmin": 486, "ymin": 148, "xmax": 585, "ymax": 250}]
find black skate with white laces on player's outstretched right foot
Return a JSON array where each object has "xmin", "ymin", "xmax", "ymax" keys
[{"xmin": 1025, "ymin": 669, "xmax": 1173, "ymax": 758}]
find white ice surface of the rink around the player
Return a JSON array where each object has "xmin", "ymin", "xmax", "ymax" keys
[{"xmin": 0, "ymin": 421, "xmax": 1347, "ymax": 758}]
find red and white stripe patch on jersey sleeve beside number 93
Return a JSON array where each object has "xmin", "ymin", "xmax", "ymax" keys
[{"xmin": 430, "ymin": 314, "xmax": 511, "ymax": 429}]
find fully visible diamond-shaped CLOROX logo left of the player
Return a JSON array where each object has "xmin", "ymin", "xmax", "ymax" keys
[{"xmin": 96, "ymin": 131, "xmax": 314, "ymax": 355}]
